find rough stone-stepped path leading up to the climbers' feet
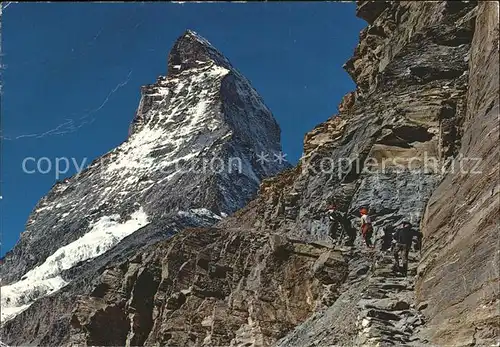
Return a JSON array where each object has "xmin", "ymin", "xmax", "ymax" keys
[{"xmin": 276, "ymin": 239, "xmax": 430, "ymax": 347}]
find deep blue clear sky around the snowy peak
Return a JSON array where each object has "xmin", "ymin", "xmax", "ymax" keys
[{"xmin": 1, "ymin": 2, "xmax": 365, "ymax": 254}]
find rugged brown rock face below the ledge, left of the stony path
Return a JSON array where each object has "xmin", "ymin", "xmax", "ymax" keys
[{"xmin": 66, "ymin": 229, "xmax": 347, "ymax": 346}]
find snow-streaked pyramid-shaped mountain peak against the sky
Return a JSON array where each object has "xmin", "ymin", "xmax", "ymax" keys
[{"xmin": 0, "ymin": 31, "xmax": 288, "ymax": 322}]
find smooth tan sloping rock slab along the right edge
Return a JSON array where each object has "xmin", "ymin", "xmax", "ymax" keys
[{"xmin": 417, "ymin": 1, "xmax": 500, "ymax": 346}]
